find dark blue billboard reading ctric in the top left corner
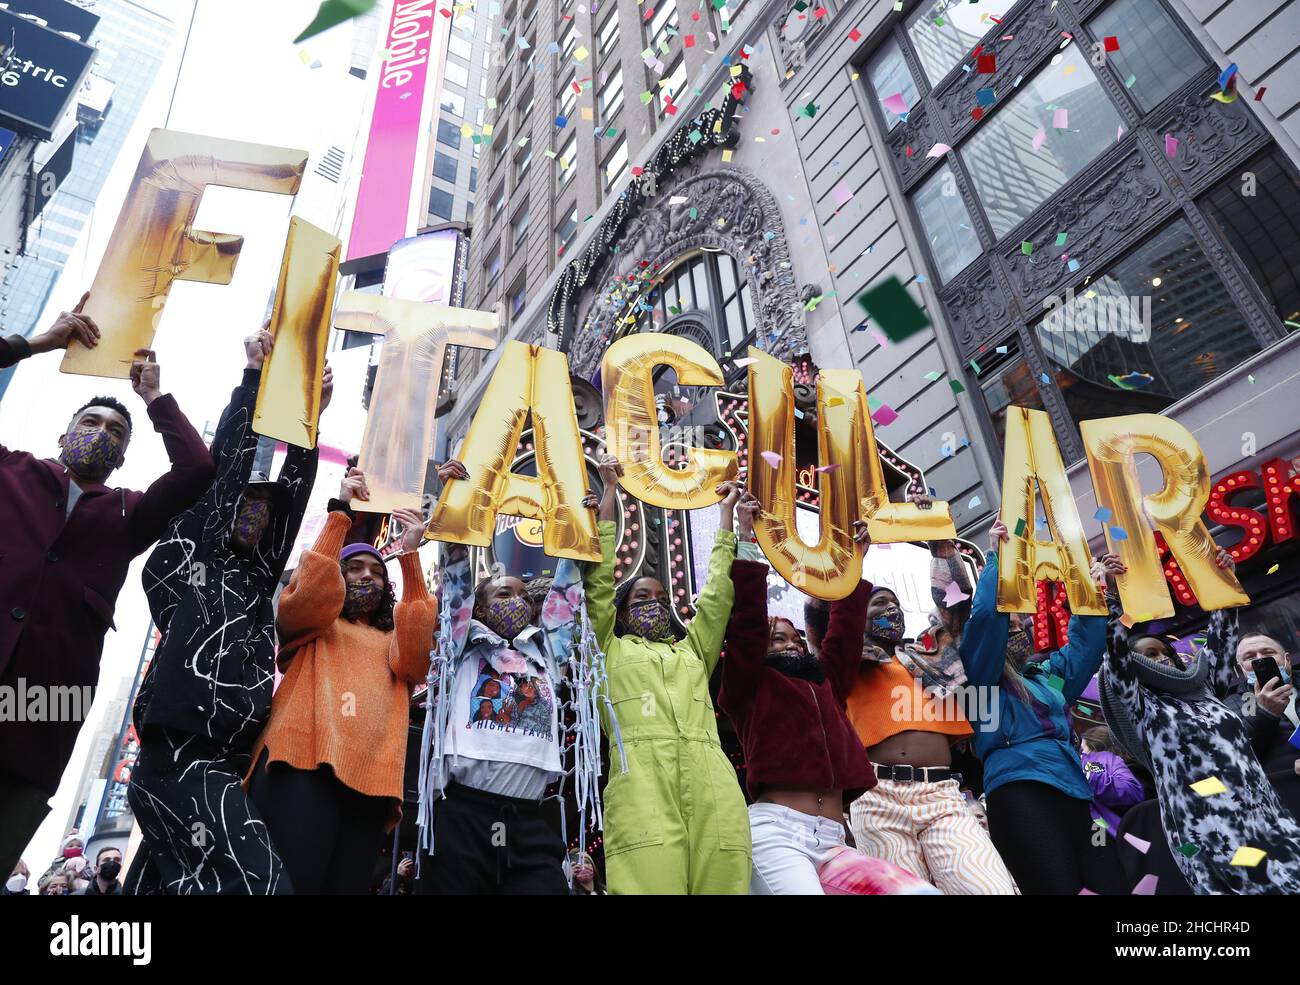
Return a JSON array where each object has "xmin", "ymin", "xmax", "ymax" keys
[{"xmin": 0, "ymin": 10, "xmax": 95, "ymax": 140}]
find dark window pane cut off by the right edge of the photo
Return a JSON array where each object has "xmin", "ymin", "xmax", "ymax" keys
[{"xmin": 1201, "ymin": 152, "xmax": 1300, "ymax": 331}]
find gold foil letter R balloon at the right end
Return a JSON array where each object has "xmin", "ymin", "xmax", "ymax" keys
[{"xmin": 1080, "ymin": 413, "xmax": 1251, "ymax": 622}]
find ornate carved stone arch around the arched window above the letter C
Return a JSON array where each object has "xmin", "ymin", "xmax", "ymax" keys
[{"xmin": 560, "ymin": 168, "xmax": 807, "ymax": 378}]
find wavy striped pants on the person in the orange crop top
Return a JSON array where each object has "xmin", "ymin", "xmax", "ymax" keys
[{"xmin": 849, "ymin": 780, "xmax": 1017, "ymax": 897}]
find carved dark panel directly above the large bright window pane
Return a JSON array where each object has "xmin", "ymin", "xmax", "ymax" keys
[{"xmin": 926, "ymin": 0, "xmax": 1069, "ymax": 149}]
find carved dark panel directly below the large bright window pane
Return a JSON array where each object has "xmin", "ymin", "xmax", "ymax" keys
[{"xmin": 1002, "ymin": 144, "xmax": 1178, "ymax": 317}]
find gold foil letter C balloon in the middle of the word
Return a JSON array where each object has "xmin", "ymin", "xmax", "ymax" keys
[{"xmin": 601, "ymin": 331, "xmax": 740, "ymax": 509}]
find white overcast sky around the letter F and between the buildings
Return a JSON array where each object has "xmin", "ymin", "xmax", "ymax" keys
[{"xmin": 0, "ymin": 0, "xmax": 379, "ymax": 881}]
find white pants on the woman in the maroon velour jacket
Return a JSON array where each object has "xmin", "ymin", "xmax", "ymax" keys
[{"xmin": 749, "ymin": 803, "xmax": 844, "ymax": 897}]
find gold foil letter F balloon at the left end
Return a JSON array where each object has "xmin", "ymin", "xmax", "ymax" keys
[{"xmin": 60, "ymin": 130, "xmax": 307, "ymax": 379}]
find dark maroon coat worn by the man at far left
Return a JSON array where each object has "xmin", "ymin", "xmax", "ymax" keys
[{"xmin": 0, "ymin": 339, "xmax": 213, "ymax": 794}]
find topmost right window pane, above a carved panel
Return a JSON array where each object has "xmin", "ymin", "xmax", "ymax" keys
[{"xmin": 1088, "ymin": 0, "xmax": 1205, "ymax": 110}]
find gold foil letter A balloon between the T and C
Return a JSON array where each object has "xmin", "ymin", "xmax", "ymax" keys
[{"xmin": 426, "ymin": 342, "xmax": 601, "ymax": 561}]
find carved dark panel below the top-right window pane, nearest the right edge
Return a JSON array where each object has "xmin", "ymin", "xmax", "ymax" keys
[{"xmin": 1153, "ymin": 83, "xmax": 1269, "ymax": 195}]
